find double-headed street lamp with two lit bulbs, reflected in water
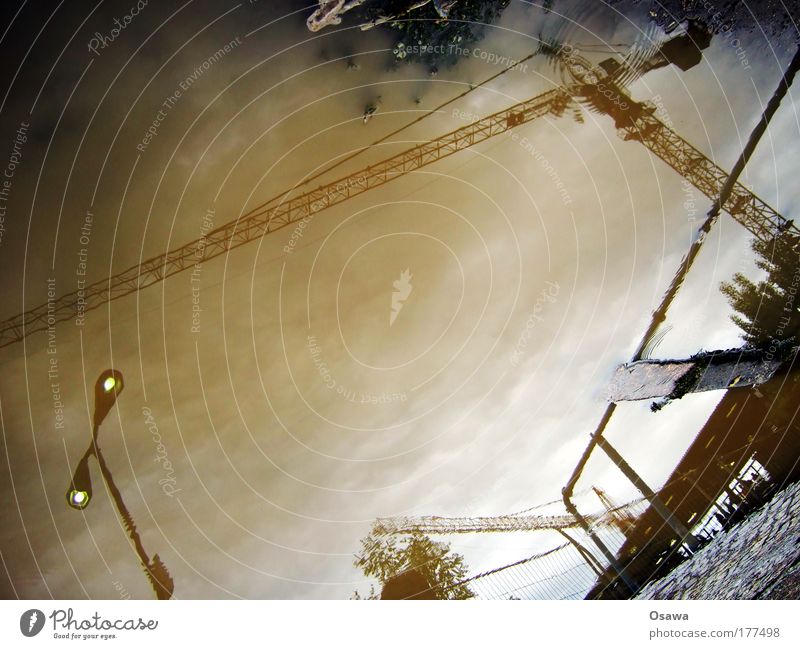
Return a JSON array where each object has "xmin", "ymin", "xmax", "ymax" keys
[{"xmin": 67, "ymin": 370, "xmax": 175, "ymax": 599}]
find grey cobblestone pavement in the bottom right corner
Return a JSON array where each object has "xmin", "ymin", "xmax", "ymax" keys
[{"xmin": 636, "ymin": 483, "xmax": 800, "ymax": 599}]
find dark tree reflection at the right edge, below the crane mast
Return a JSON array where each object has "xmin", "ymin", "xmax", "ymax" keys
[{"xmin": 720, "ymin": 234, "xmax": 800, "ymax": 349}]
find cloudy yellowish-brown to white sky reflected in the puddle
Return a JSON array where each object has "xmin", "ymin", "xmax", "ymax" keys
[{"xmin": 0, "ymin": 1, "xmax": 800, "ymax": 598}]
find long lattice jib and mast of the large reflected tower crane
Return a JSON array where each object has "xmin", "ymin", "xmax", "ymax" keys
[{"xmin": 0, "ymin": 52, "xmax": 800, "ymax": 347}]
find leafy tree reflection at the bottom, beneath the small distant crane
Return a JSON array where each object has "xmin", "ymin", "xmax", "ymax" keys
[{"xmin": 353, "ymin": 529, "xmax": 475, "ymax": 599}]
